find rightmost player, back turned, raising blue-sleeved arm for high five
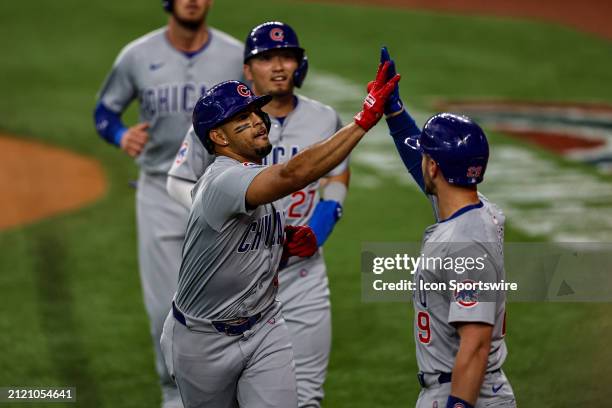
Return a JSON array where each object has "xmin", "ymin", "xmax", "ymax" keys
[{"xmin": 381, "ymin": 48, "xmax": 516, "ymax": 408}]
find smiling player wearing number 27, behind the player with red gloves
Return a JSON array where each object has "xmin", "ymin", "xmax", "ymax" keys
[{"xmin": 168, "ymin": 22, "xmax": 349, "ymax": 407}]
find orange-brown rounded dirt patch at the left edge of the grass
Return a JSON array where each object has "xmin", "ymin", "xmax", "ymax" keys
[{"xmin": 0, "ymin": 135, "xmax": 106, "ymax": 230}]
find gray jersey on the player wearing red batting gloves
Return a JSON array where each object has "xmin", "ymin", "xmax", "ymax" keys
[{"xmin": 175, "ymin": 156, "xmax": 285, "ymax": 320}]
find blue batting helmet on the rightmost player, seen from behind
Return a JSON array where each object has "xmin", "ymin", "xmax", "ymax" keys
[{"xmin": 406, "ymin": 113, "xmax": 489, "ymax": 186}]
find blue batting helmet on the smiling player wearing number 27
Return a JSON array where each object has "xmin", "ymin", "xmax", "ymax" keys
[{"xmin": 244, "ymin": 21, "xmax": 308, "ymax": 88}]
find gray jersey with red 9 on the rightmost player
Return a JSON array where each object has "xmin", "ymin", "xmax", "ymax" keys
[{"xmin": 414, "ymin": 195, "xmax": 507, "ymax": 373}]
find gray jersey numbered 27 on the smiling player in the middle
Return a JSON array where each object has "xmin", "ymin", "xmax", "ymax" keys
[{"xmin": 168, "ymin": 95, "xmax": 348, "ymax": 230}]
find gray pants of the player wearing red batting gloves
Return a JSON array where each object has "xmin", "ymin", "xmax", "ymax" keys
[{"xmin": 161, "ymin": 302, "xmax": 297, "ymax": 408}]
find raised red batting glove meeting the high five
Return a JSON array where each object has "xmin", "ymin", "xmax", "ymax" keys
[{"xmin": 354, "ymin": 61, "xmax": 400, "ymax": 131}]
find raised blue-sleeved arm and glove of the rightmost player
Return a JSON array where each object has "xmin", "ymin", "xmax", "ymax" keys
[{"xmin": 380, "ymin": 47, "xmax": 425, "ymax": 191}]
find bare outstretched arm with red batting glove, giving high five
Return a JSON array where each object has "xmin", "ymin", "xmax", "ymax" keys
[{"xmin": 246, "ymin": 63, "xmax": 399, "ymax": 207}]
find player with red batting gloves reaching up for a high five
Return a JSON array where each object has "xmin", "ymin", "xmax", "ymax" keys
[{"xmin": 161, "ymin": 73, "xmax": 399, "ymax": 408}]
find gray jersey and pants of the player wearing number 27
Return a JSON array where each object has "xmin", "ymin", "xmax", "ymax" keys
[{"xmin": 169, "ymin": 96, "xmax": 348, "ymax": 407}]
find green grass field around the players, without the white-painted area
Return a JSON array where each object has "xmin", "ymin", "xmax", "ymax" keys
[{"xmin": 0, "ymin": 0, "xmax": 612, "ymax": 407}]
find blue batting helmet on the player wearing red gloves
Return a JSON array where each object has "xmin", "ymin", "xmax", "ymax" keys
[{"xmin": 192, "ymin": 81, "xmax": 272, "ymax": 154}]
